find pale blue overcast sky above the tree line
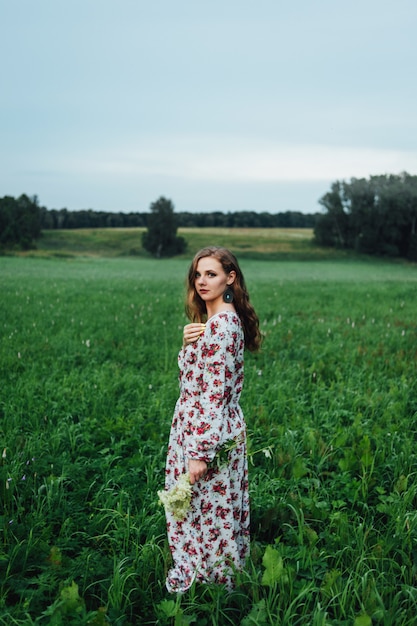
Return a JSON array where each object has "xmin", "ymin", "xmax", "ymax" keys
[{"xmin": 0, "ymin": 0, "xmax": 417, "ymax": 213}]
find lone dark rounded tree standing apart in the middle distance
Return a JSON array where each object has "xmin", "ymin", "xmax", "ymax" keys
[{"xmin": 142, "ymin": 196, "xmax": 187, "ymax": 258}]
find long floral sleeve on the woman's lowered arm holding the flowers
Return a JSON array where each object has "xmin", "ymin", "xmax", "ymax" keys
[{"xmin": 185, "ymin": 315, "xmax": 237, "ymax": 463}]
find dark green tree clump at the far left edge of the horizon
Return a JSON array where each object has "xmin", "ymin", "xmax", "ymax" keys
[{"xmin": 0, "ymin": 195, "xmax": 41, "ymax": 250}]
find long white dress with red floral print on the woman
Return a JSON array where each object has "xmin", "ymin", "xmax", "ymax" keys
[{"xmin": 165, "ymin": 311, "xmax": 249, "ymax": 593}]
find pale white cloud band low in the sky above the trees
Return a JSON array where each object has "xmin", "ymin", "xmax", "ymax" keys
[{"xmin": 53, "ymin": 137, "xmax": 417, "ymax": 183}]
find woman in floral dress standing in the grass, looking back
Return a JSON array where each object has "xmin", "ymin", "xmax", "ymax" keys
[{"xmin": 165, "ymin": 247, "xmax": 261, "ymax": 592}]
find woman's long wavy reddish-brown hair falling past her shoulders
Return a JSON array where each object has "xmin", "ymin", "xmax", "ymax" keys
[{"xmin": 185, "ymin": 246, "xmax": 262, "ymax": 352}]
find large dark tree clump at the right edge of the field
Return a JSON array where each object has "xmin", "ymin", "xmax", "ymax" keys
[{"xmin": 314, "ymin": 173, "xmax": 417, "ymax": 261}]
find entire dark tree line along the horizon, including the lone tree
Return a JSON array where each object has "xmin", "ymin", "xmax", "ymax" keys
[{"xmin": 0, "ymin": 172, "xmax": 417, "ymax": 261}]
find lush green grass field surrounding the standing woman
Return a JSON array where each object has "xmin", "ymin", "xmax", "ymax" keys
[{"xmin": 0, "ymin": 250, "xmax": 417, "ymax": 626}]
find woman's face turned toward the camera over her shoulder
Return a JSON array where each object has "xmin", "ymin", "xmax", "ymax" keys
[{"xmin": 194, "ymin": 256, "xmax": 232, "ymax": 305}]
